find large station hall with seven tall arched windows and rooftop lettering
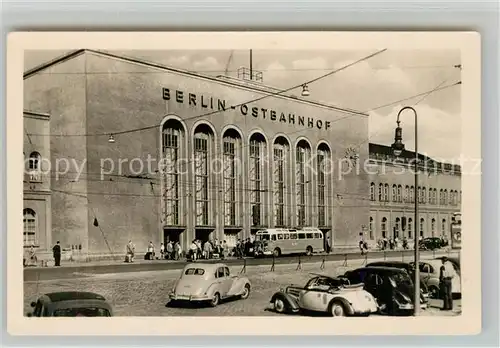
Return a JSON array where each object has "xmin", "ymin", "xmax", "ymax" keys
[{"xmin": 24, "ymin": 50, "xmax": 370, "ymax": 255}]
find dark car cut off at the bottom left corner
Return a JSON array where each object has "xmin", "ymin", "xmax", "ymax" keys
[{"xmin": 27, "ymin": 291, "xmax": 113, "ymax": 317}]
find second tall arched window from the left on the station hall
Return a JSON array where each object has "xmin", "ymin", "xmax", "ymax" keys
[{"xmin": 194, "ymin": 124, "xmax": 214, "ymax": 226}]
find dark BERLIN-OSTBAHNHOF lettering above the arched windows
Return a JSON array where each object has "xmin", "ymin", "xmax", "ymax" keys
[{"xmin": 162, "ymin": 88, "xmax": 330, "ymax": 129}]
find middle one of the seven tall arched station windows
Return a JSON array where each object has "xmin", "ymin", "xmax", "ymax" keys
[{"xmin": 249, "ymin": 133, "xmax": 266, "ymax": 226}]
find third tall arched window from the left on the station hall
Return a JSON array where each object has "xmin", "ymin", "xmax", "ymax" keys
[{"xmin": 222, "ymin": 129, "xmax": 241, "ymax": 226}]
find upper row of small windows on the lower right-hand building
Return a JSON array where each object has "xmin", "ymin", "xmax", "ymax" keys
[{"xmin": 370, "ymin": 182, "xmax": 462, "ymax": 206}]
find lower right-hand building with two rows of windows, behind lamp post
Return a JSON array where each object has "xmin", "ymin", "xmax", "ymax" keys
[{"xmin": 367, "ymin": 144, "xmax": 462, "ymax": 243}]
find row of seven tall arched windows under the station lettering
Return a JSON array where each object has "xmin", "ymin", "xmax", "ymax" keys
[{"xmin": 162, "ymin": 119, "xmax": 331, "ymax": 227}]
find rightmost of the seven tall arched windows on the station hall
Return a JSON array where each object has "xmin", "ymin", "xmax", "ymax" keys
[{"xmin": 316, "ymin": 143, "xmax": 330, "ymax": 226}]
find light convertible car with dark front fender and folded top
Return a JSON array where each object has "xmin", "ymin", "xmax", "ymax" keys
[{"xmin": 270, "ymin": 274, "xmax": 378, "ymax": 317}]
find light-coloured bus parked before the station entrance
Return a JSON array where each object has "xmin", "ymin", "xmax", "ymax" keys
[{"xmin": 255, "ymin": 227, "xmax": 325, "ymax": 257}]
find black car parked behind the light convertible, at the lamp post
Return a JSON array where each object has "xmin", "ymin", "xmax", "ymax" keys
[{"xmin": 343, "ymin": 267, "xmax": 427, "ymax": 315}]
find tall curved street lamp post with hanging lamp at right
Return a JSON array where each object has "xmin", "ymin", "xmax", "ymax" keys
[{"xmin": 392, "ymin": 106, "xmax": 420, "ymax": 316}]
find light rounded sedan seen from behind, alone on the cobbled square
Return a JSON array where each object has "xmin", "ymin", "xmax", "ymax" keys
[{"xmin": 170, "ymin": 262, "xmax": 250, "ymax": 307}]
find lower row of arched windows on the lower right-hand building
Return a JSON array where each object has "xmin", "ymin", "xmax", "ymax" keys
[{"xmin": 369, "ymin": 217, "xmax": 448, "ymax": 239}]
